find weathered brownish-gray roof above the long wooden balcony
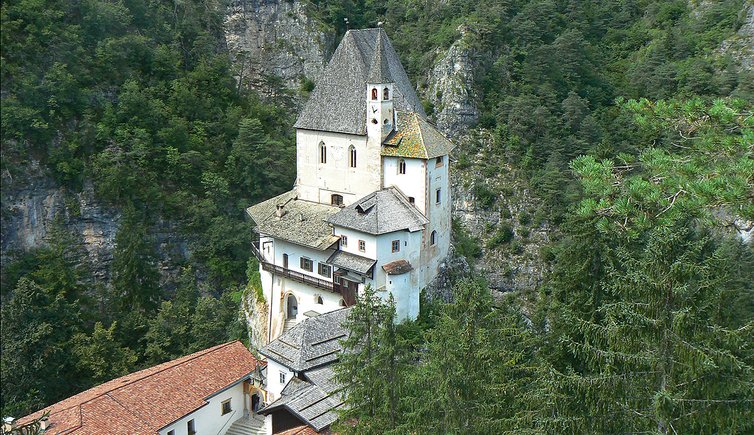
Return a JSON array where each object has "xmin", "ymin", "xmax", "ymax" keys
[{"xmin": 246, "ymin": 189, "xmax": 340, "ymax": 250}]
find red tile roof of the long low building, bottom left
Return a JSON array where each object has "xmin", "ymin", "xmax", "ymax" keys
[{"xmin": 18, "ymin": 341, "xmax": 260, "ymax": 435}]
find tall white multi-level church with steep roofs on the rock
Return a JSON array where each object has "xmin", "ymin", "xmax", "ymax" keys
[{"xmin": 247, "ymin": 28, "xmax": 453, "ymax": 341}]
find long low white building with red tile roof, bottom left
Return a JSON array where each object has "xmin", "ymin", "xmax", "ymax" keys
[{"xmin": 15, "ymin": 341, "xmax": 265, "ymax": 435}]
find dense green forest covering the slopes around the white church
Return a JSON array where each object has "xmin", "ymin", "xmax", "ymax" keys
[{"xmin": 0, "ymin": 0, "xmax": 754, "ymax": 426}]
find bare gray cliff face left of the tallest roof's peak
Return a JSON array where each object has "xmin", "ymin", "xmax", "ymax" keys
[{"xmin": 220, "ymin": 0, "xmax": 334, "ymax": 89}]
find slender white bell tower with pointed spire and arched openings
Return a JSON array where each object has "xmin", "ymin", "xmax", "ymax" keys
[{"xmin": 366, "ymin": 29, "xmax": 395, "ymax": 147}]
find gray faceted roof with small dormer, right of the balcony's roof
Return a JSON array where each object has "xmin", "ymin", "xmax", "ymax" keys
[{"xmin": 327, "ymin": 187, "xmax": 429, "ymax": 235}]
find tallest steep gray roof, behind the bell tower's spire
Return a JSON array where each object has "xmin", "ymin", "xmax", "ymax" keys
[{"xmin": 294, "ymin": 28, "xmax": 426, "ymax": 135}]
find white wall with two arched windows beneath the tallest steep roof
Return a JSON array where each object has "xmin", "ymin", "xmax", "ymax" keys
[{"xmin": 296, "ymin": 129, "xmax": 382, "ymax": 205}]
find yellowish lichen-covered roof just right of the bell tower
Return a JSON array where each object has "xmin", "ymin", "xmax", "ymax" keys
[{"xmin": 382, "ymin": 111, "xmax": 455, "ymax": 159}]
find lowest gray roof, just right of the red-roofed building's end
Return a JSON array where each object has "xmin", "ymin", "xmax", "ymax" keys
[{"xmin": 261, "ymin": 367, "xmax": 343, "ymax": 432}]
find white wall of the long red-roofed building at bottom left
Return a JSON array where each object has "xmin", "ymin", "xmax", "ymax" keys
[{"xmin": 159, "ymin": 382, "xmax": 245, "ymax": 435}]
